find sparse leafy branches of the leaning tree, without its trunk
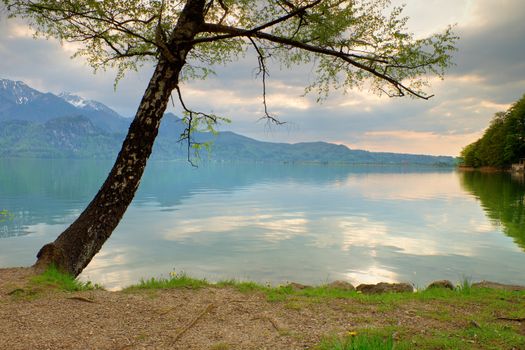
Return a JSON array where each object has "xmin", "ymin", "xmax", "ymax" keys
[{"xmin": 2, "ymin": 0, "xmax": 457, "ymax": 121}]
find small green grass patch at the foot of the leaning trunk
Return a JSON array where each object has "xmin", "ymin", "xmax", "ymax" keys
[{"xmin": 31, "ymin": 265, "xmax": 98, "ymax": 292}]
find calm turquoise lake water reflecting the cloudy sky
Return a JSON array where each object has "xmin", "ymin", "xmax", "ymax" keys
[{"xmin": 0, "ymin": 159, "xmax": 525, "ymax": 289}]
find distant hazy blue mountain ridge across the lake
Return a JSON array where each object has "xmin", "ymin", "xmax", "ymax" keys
[{"xmin": 0, "ymin": 79, "xmax": 455, "ymax": 165}]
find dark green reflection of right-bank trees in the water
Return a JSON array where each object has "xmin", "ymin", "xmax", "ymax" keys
[{"xmin": 461, "ymin": 172, "xmax": 525, "ymax": 249}]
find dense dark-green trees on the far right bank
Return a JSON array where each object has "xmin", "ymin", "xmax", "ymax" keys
[{"xmin": 461, "ymin": 95, "xmax": 525, "ymax": 168}]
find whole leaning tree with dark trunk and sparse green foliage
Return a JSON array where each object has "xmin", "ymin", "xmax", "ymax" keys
[{"xmin": 2, "ymin": 0, "xmax": 457, "ymax": 276}]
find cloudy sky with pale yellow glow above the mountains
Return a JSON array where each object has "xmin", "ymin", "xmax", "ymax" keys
[{"xmin": 0, "ymin": 0, "xmax": 525, "ymax": 156}]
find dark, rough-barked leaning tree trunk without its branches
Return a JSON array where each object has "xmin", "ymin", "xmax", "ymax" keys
[{"xmin": 35, "ymin": 0, "xmax": 204, "ymax": 276}]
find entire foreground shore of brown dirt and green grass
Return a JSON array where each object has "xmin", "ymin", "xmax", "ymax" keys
[{"xmin": 0, "ymin": 268, "xmax": 525, "ymax": 350}]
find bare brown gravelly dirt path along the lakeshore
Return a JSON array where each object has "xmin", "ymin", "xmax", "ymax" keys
[{"xmin": 0, "ymin": 269, "xmax": 525, "ymax": 350}]
